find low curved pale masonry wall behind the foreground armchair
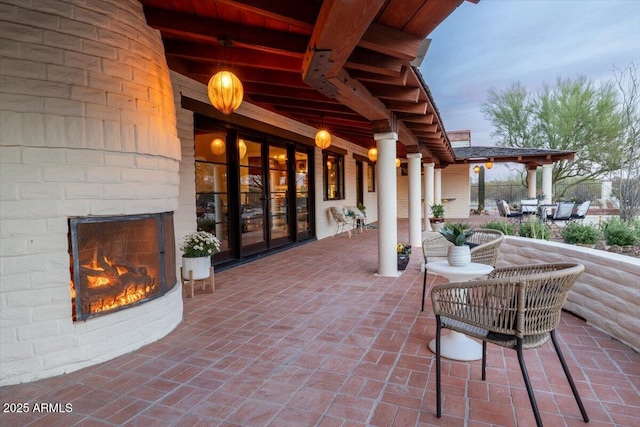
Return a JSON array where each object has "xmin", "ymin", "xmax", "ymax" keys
[{"xmin": 498, "ymin": 236, "xmax": 640, "ymax": 352}]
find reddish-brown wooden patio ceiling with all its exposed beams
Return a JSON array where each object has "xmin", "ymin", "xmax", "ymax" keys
[{"xmin": 140, "ymin": 0, "xmax": 472, "ymax": 166}]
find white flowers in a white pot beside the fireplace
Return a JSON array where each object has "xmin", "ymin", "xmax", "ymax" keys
[{"xmin": 180, "ymin": 231, "xmax": 220, "ymax": 280}]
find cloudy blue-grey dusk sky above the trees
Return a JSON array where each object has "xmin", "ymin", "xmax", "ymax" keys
[{"xmin": 420, "ymin": 0, "xmax": 640, "ymax": 179}]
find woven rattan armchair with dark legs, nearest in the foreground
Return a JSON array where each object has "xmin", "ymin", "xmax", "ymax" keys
[{"xmin": 431, "ymin": 263, "xmax": 589, "ymax": 426}]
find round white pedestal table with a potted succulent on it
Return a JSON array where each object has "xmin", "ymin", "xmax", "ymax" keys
[{"xmin": 427, "ymin": 261, "xmax": 493, "ymax": 362}]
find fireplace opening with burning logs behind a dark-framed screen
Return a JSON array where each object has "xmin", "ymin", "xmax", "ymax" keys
[{"xmin": 69, "ymin": 212, "xmax": 176, "ymax": 320}]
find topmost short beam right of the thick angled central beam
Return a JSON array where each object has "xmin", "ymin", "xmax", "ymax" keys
[{"xmin": 358, "ymin": 22, "xmax": 422, "ymax": 61}]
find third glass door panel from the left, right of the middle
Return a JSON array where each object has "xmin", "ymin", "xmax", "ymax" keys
[{"xmin": 269, "ymin": 146, "xmax": 289, "ymax": 241}]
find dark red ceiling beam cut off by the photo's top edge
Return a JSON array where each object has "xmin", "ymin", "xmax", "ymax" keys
[{"xmin": 217, "ymin": 0, "xmax": 318, "ymax": 31}]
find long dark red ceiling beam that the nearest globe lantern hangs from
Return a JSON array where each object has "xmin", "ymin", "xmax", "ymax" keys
[{"xmin": 144, "ymin": 7, "xmax": 309, "ymax": 57}]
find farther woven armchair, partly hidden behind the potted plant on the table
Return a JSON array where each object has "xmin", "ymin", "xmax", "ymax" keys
[{"xmin": 420, "ymin": 228, "xmax": 504, "ymax": 311}]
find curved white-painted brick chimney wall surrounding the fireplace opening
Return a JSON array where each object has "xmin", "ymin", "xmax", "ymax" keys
[{"xmin": 0, "ymin": 0, "xmax": 182, "ymax": 385}]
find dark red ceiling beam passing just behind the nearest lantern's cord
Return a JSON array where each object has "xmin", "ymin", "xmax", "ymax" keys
[{"xmin": 164, "ymin": 40, "xmax": 302, "ymax": 71}]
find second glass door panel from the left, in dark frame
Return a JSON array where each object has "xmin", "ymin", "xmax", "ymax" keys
[{"xmin": 239, "ymin": 139, "xmax": 266, "ymax": 248}]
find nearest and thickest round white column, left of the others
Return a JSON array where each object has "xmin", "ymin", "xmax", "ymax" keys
[{"xmin": 373, "ymin": 132, "xmax": 398, "ymax": 277}]
